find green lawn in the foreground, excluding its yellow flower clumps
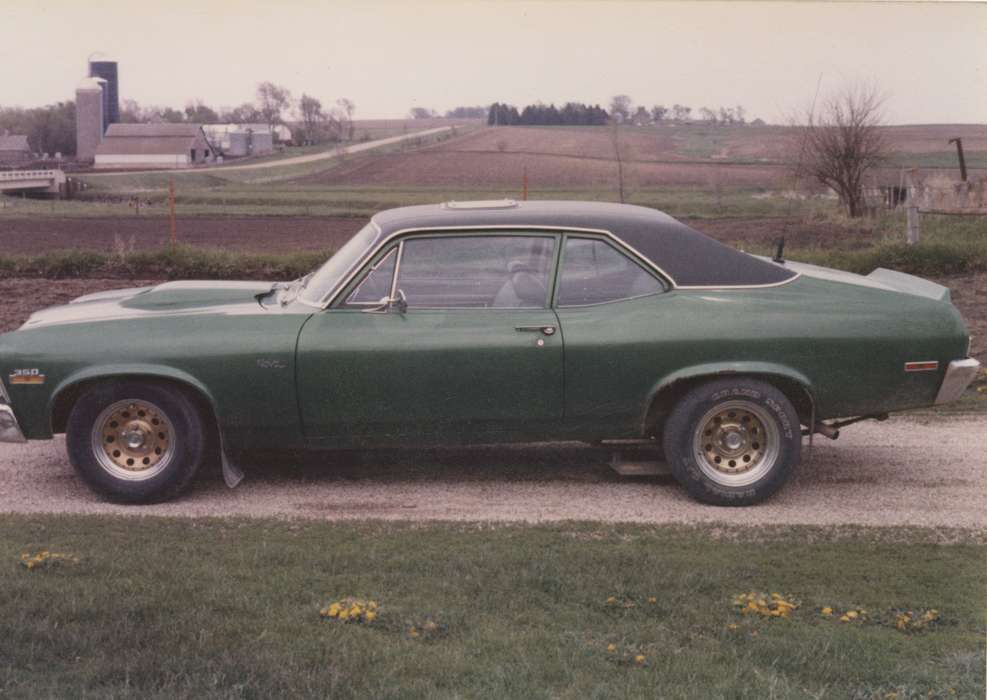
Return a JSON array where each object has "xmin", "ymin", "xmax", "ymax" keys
[{"xmin": 0, "ymin": 515, "xmax": 987, "ymax": 700}]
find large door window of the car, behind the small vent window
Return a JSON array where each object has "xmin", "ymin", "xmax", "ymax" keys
[{"xmin": 397, "ymin": 235, "xmax": 555, "ymax": 309}]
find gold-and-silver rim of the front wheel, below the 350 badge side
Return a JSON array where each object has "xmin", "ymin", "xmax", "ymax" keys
[{"xmin": 92, "ymin": 399, "xmax": 175, "ymax": 481}]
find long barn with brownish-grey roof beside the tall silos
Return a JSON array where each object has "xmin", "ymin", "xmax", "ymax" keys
[{"xmin": 96, "ymin": 124, "xmax": 216, "ymax": 168}]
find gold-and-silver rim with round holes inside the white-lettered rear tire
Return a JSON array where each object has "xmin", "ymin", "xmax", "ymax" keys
[{"xmin": 693, "ymin": 400, "xmax": 781, "ymax": 487}]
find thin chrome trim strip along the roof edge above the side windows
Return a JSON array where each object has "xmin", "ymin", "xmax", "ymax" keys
[{"xmin": 312, "ymin": 219, "xmax": 802, "ymax": 310}]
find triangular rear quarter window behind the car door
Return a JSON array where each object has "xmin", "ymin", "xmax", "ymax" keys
[{"xmin": 558, "ymin": 236, "xmax": 664, "ymax": 306}]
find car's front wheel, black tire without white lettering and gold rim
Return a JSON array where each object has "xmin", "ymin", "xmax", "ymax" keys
[{"xmin": 66, "ymin": 381, "xmax": 205, "ymax": 503}]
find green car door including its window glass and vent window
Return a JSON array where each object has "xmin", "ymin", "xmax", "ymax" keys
[{"xmin": 297, "ymin": 232, "xmax": 563, "ymax": 444}]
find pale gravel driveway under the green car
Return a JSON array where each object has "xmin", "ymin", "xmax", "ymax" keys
[{"xmin": 0, "ymin": 417, "xmax": 987, "ymax": 530}]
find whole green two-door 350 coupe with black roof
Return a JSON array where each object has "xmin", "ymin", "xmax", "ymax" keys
[{"xmin": 0, "ymin": 201, "xmax": 979, "ymax": 505}]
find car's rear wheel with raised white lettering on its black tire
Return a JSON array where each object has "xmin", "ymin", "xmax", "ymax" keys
[{"xmin": 662, "ymin": 378, "xmax": 802, "ymax": 506}]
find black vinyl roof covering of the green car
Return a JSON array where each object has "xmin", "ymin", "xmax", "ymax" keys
[{"xmin": 373, "ymin": 201, "xmax": 797, "ymax": 287}]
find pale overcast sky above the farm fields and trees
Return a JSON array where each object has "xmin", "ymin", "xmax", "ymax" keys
[{"xmin": 0, "ymin": 0, "xmax": 987, "ymax": 123}]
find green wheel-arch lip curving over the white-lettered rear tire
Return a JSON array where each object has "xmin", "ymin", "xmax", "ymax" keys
[{"xmin": 641, "ymin": 362, "xmax": 815, "ymax": 436}]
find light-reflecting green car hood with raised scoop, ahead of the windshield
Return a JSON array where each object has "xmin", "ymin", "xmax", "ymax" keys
[{"xmin": 21, "ymin": 281, "xmax": 272, "ymax": 329}]
